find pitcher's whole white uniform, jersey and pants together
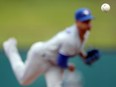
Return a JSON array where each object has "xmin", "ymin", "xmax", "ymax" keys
[{"xmin": 3, "ymin": 25, "xmax": 88, "ymax": 87}]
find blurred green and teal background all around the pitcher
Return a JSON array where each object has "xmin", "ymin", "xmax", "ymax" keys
[{"xmin": 0, "ymin": 0, "xmax": 116, "ymax": 87}]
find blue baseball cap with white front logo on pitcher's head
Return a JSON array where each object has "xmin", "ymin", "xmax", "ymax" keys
[{"xmin": 75, "ymin": 8, "xmax": 93, "ymax": 22}]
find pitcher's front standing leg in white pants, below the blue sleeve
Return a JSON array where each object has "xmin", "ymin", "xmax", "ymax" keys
[{"xmin": 45, "ymin": 67, "xmax": 63, "ymax": 87}]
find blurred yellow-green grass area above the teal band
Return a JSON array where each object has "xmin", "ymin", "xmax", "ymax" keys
[{"xmin": 0, "ymin": 0, "xmax": 116, "ymax": 48}]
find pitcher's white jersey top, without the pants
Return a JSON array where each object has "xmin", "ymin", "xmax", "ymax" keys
[{"xmin": 44, "ymin": 25, "xmax": 89, "ymax": 61}]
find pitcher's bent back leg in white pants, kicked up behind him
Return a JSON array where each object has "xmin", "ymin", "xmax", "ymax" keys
[{"xmin": 3, "ymin": 39, "xmax": 47, "ymax": 85}]
